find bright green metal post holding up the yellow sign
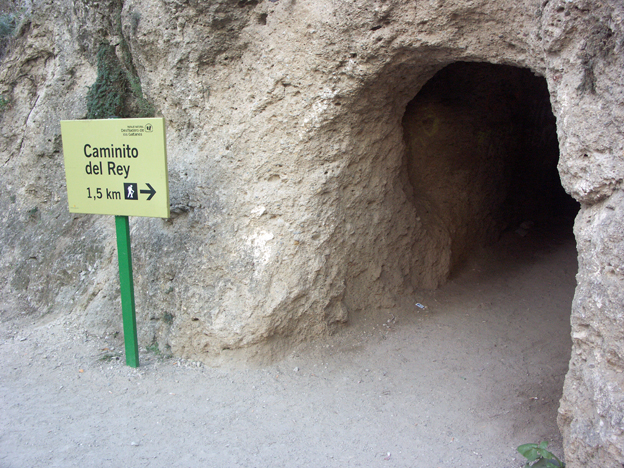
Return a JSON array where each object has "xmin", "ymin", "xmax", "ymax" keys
[{"xmin": 115, "ymin": 216, "xmax": 139, "ymax": 367}]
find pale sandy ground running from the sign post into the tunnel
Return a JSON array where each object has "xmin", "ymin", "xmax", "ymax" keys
[{"xmin": 0, "ymin": 221, "xmax": 577, "ymax": 468}]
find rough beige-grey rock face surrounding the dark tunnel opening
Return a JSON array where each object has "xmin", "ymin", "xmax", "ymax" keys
[{"xmin": 0, "ymin": 0, "xmax": 624, "ymax": 462}]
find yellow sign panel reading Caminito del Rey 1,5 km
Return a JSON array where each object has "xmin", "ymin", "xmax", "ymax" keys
[{"xmin": 61, "ymin": 118, "xmax": 169, "ymax": 218}]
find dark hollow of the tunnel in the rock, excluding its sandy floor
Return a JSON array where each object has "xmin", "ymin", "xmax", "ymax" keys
[{"xmin": 403, "ymin": 62, "xmax": 578, "ymax": 287}]
